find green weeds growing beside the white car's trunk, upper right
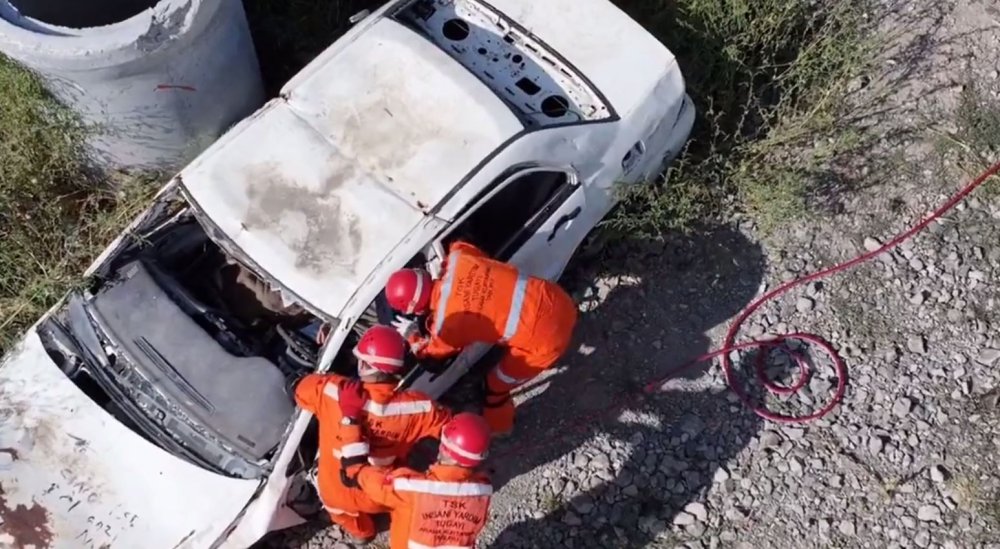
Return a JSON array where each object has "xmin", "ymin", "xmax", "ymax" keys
[{"xmin": 606, "ymin": 0, "xmax": 874, "ymax": 235}]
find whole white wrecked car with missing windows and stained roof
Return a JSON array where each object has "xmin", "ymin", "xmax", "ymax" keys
[{"xmin": 0, "ymin": 0, "xmax": 694, "ymax": 549}]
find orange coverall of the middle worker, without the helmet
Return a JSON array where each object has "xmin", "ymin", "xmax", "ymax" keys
[{"xmin": 295, "ymin": 374, "xmax": 451, "ymax": 538}]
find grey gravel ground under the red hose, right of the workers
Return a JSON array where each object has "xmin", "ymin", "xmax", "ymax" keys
[{"xmin": 273, "ymin": 0, "xmax": 1000, "ymax": 549}]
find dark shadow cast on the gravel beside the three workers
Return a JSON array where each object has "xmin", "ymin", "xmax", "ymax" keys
[{"xmin": 489, "ymin": 224, "xmax": 765, "ymax": 548}]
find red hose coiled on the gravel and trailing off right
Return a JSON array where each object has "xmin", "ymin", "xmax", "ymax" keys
[{"xmin": 644, "ymin": 158, "xmax": 1000, "ymax": 423}]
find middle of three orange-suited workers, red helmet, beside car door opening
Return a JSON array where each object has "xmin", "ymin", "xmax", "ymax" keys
[{"xmin": 295, "ymin": 326, "xmax": 451, "ymax": 543}]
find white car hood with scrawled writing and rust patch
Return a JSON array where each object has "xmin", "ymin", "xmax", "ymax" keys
[{"xmin": 0, "ymin": 329, "xmax": 259, "ymax": 549}]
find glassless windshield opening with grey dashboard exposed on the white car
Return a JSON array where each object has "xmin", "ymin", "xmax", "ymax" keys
[{"xmin": 39, "ymin": 195, "xmax": 323, "ymax": 478}]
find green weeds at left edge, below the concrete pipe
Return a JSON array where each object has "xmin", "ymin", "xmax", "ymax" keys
[{"xmin": 0, "ymin": 56, "xmax": 151, "ymax": 352}]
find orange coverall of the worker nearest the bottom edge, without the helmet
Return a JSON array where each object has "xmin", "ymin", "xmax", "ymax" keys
[{"xmin": 341, "ymin": 425, "xmax": 493, "ymax": 549}]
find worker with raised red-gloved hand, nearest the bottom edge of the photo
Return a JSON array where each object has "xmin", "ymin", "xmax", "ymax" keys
[{"xmin": 340, "ymin": 374, "xmax": 493, "ymax": 549}]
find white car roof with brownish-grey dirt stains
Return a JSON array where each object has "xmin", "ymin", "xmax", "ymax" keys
[{"xmin": 180, "ymin": 19, "xmax": 523, "ymax": 316}]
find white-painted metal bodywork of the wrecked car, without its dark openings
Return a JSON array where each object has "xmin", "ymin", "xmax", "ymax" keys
[{"xmin": 0, "ymin": 0, "xmax": 694, "ymax": 548}]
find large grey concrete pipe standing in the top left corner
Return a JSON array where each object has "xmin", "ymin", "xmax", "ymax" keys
[{"xmin": 0, "ymin": 0, "xmax": 264, "ymax": 170}]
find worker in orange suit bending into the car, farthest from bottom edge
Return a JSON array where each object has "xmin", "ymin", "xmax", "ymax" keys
[{"xmin": 385, "ymin": 241, "xmax": 577, "ymax": 435}]
